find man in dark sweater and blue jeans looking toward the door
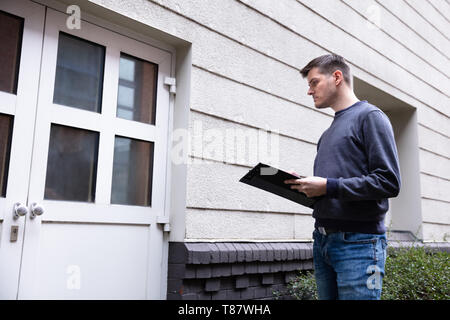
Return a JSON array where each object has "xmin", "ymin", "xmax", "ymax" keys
[{"xmin": 285, "ymin": 54, "xmax": 401, "ymax": 299}]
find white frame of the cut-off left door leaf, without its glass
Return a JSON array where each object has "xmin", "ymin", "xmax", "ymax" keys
[{"xmin": 0, "ymin": 0, "xmax": 45, "ymax": 299}]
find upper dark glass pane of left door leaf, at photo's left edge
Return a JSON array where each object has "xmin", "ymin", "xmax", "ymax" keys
[{"xmin": 0, "ymin": 11, "xmax": 23, "ymax": 94}]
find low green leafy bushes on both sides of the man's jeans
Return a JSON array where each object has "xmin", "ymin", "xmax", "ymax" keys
[{"xmin": 287, "ymin": 247, "xmax": 450, "ymax": 300}]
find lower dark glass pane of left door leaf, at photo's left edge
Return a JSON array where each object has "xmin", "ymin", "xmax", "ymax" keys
[{"xmin": 0, "ymin": 114, "xmax": 14, "ymax": 197}]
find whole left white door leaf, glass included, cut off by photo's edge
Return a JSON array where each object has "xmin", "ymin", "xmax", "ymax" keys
[{"xmin": 0, "ymin": 0, "xmax": 45, "ymax": 299}]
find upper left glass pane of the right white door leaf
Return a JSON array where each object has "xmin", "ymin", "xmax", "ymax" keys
[{"xmin": 53, "ymin": 32, "xmax": 105, "ymax": 112}]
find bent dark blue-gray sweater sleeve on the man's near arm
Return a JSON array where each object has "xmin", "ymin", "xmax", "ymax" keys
[{"xmin": 327, "ymin": 110, "xmax": 401, "ymax": 201}]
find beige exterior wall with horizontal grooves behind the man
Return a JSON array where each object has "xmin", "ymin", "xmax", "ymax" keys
[{"xmin": 91, "ymin": 0, "xmax": 450, "ymax": 241}]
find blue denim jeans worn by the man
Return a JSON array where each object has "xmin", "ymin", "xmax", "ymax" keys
[{"xmin": 313, "ymin": 230, "xmax": 387, "ymax": 300}]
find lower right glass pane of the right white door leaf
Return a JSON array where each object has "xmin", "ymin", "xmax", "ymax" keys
[{"xmin": 111, "ymin": 136, "xmax": 154, "ymax": 206}]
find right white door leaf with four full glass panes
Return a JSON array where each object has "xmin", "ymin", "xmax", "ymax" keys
[{"xmin": 2, "ymin": 1, "xmax": 171, "ymax": 299}]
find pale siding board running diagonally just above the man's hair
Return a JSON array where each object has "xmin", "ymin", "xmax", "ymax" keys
[{"xmin": 242, "ymin": 0, "xmax": 450, "ymax": 116}]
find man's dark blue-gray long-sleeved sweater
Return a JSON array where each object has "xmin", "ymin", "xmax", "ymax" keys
[{"xmin": 313, "ymin": 101, "xmax": 401, "ymax": 234}]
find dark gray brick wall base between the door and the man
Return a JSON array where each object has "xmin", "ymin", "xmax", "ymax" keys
[{"xmin": 167, "ymin": 242, "xmax": 313, "ymax": 300}]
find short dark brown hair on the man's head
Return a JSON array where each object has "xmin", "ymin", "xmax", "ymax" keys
[{"xmin": 300, "ymin": 54, "xmax": 352, "ymax": 87}]
